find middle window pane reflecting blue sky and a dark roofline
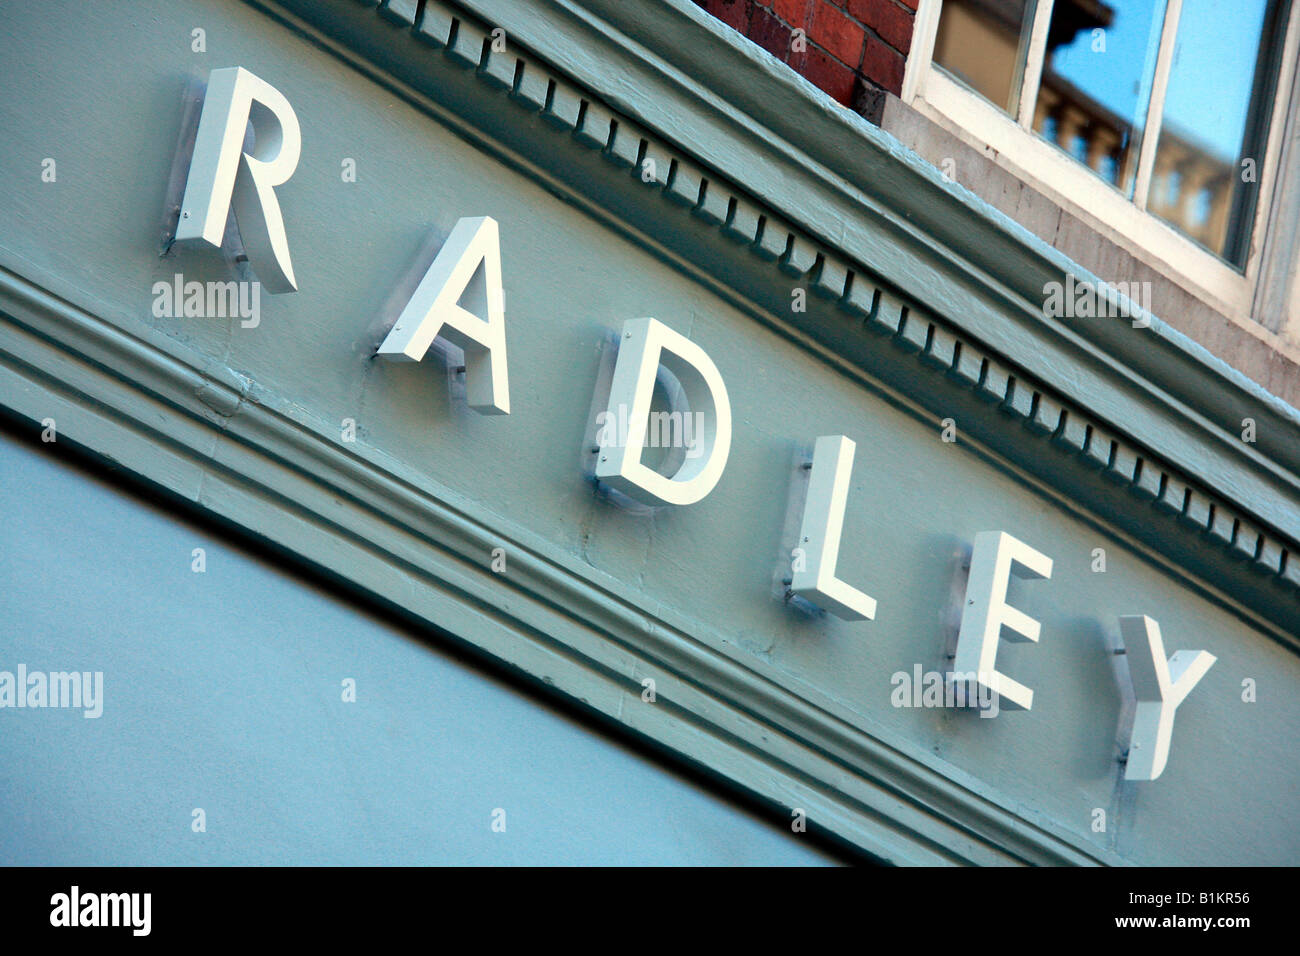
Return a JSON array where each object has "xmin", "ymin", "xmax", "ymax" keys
[{"xmin": 1034, "ymin": 0, "xmax": 1165, "ymax": 196}]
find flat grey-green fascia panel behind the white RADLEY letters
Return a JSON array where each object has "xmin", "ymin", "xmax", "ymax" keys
[{"xmin": 0, "ymin": 0, "xmax": 1300, "ymax": 864}]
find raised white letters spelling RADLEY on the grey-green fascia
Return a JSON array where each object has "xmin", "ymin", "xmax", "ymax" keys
[{"xmin": 164, "ymin": 68, "xmax": 1216, "ymax": 780}]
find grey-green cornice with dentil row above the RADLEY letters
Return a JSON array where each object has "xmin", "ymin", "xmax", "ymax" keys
[{"xmin": 276, "ymin": 0, "xmax": 1300, "ymax": 639}]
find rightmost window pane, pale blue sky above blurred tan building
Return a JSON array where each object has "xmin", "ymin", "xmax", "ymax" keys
[{"xmin": 1147, "ymin": 0, "xmax": 1282, "ymax": 267}]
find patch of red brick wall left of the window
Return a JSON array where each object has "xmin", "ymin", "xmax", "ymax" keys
[{"xmin": 696, "ymin": 0, "xmax": 918, "ymax": 122}]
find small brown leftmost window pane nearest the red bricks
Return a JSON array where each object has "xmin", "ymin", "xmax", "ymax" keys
[{"xmin": 935, "ymin": 0, "xmax": 1035, "ymax": 116}]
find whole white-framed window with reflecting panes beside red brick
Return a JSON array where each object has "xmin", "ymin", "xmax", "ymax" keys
[{"xmin": 904, "ymin": 0, "xmax": 1297, "ymax": 321}]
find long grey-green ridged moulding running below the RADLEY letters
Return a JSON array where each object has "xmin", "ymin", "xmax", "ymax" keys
[{"xmin": 0, "ymin": 269, "xmax": 1122, "ymax": 865}]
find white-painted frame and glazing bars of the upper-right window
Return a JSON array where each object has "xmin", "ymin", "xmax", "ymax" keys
[{"xmin": 901, "ymin": 0, "xmax": 1300, "ymax": 325}]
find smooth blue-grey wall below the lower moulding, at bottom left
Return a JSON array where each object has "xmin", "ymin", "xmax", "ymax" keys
[{"xmin": 0, "ymin": 434, "xmax": 828, "ymax": 865}]
